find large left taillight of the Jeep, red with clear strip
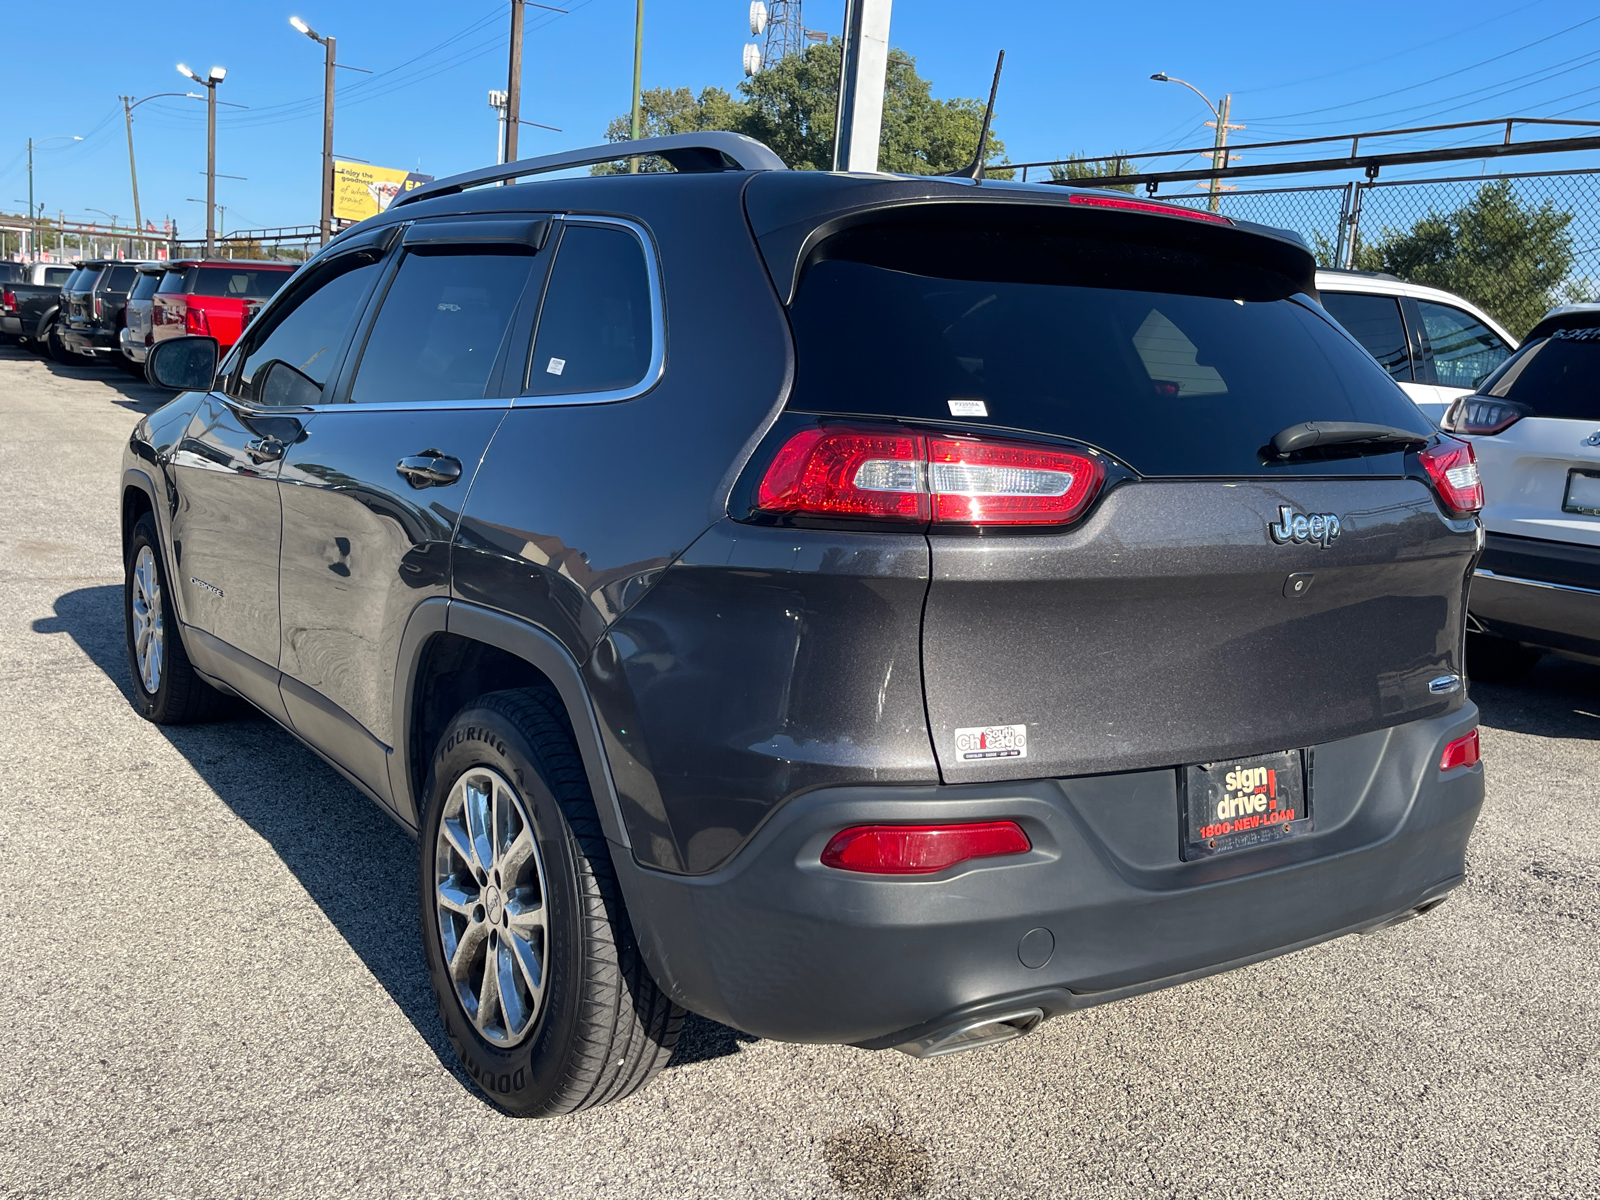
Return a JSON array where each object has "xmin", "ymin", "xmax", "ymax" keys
[{"xmin": 755, "ymin": 426, "xmax": 1106, "ymax": 525}]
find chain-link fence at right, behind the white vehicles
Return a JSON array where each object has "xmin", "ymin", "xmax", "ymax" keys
[{"xmin": 1158, "ymin": 171, "xmax": 1600, "ymax": 338}]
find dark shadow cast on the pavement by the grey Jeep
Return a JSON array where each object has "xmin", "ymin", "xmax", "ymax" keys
[{"xmin": 34, "ymin": 586, "xmax": 755, "ymax": 1090}]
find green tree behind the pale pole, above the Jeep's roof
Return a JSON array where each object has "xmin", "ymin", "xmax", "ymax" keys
[{"xmin": 592, "ymin": 38, "xmax": 1013, "ymax": 179}]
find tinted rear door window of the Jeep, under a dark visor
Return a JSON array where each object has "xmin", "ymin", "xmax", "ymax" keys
[{"xmin": 350, "ymin": 248, "xmax": 534, "ymax": 405}]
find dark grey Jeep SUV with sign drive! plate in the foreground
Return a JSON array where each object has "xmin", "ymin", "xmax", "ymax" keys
[{"xmin": 122, "ymin": 133, "xmax": 1483, "ymax": 1115}]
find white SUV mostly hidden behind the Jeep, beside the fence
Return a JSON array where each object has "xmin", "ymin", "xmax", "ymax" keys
[{"xmin": 1317, "ymin": 267, "xmax": 1517, "ymax": 422}]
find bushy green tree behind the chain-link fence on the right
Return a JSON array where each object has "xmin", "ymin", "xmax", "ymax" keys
[{"xmin": 1352, "ymin": 179, "xmax": 1574, "ymax": 338}]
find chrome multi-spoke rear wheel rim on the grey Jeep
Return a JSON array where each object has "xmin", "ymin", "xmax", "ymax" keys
[{"xmin": 434, "ymin": 766, "xmax": 549, "ymax": 1046}]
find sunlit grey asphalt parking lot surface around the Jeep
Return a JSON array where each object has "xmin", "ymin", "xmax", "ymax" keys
[{"xmin": 0, "ymin": 347, "xmax": 1600, "ymax": 1198}]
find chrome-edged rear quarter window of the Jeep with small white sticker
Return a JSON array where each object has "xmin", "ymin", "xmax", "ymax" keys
[{"xmin": 523, "ymin": 226, "xmax": 651, "ymax": 395}]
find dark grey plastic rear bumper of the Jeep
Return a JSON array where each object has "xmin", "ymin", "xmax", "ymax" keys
[{"xmin": 614, "ymin": 702, "xmax": 1483, "ymax": 1046}]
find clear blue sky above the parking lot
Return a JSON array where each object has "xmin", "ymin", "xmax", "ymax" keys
[{"xmin": 0, "ymin": 0, "xmax": 1600, "ymax": 234}]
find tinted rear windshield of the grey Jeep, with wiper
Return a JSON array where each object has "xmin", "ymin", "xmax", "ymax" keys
[{"xmin": 789, "ymin": 229, "xmax": 1430, "ymax": 475}]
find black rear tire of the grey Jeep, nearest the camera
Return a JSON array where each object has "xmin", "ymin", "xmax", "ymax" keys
[{"xmin": 418, "ymin": 688, "xmax": 683, "ymax": 1117}]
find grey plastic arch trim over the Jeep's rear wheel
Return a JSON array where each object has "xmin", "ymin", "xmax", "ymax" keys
[{"xmin": 389, "ymin": 597, "xmax": 632, "ymax": 850}]
